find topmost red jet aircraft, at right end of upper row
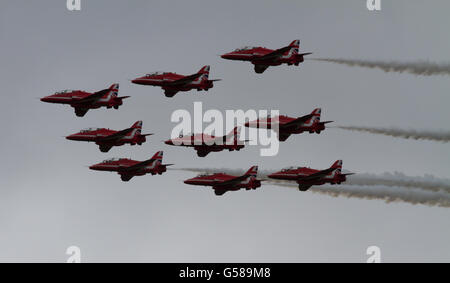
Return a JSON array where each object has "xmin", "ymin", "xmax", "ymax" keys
[{"xmin": 220, "ymin": 39, "xmax": 312, "ymax": 74}]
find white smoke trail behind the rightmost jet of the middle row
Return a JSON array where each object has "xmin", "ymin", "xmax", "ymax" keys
[{"xmin": 336, "ymin": 126, "xmax": 450, "ymax": 142}]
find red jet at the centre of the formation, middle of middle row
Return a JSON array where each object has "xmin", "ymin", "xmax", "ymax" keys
[{"xmin": 164, "ymin": 127, "xmax": 245, "ymax": 157}]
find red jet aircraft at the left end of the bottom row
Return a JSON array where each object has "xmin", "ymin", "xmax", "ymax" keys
[{"xmin": 89, "ymin": 151, "xmax": 173, "ymax": 182}]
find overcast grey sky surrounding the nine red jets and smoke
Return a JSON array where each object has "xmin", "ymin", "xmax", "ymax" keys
[{"xmin": 0, "ymin": 0, "xmax": 450, "ymax": 262}]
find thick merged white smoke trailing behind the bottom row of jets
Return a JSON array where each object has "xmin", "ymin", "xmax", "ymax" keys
[{"xmin": 173, "ymin": 168, "xmax": 450, "ymax": 207}]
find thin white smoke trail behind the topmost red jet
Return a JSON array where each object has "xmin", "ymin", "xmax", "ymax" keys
[{"xmin": 308, "ymin": 58, "xmax": 450, "ymax": 76}]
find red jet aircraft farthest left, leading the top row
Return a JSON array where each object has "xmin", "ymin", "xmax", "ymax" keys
[{"xmin": 41, "ymin": 84, "xmax": 129, "ymax": 117}]
